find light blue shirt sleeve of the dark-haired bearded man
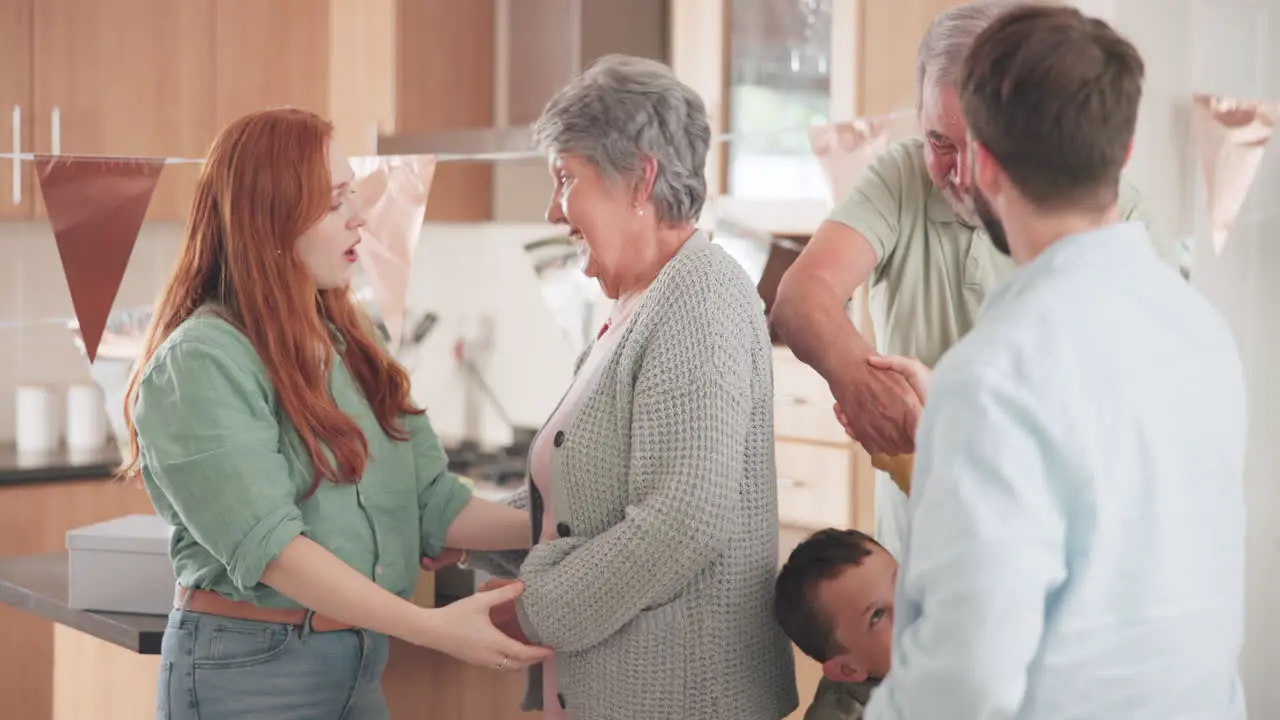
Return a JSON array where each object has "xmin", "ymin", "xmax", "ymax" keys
[{"xmin": 867, "ymin": 373, "xmax": 1071, "ymax": 720}]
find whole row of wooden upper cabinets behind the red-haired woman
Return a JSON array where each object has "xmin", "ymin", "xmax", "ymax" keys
[{"xmin": 0, "ymin": 0, "xmax": 495, "ymax": 220}]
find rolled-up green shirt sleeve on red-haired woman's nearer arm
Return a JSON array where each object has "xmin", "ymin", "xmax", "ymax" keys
[{"xmin": 133, "ymin": 342, "xmax": 306, "ymax": 589}]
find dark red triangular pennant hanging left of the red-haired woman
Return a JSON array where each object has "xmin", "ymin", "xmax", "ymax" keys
[{"xmin": 35, "ymin": 155, "xmax": 164, "ymax": 363}]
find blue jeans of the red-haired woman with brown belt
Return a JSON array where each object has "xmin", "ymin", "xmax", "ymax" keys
[{"xmin": 156, "ymin": 610, "xmax": 388, "ymax": 720}]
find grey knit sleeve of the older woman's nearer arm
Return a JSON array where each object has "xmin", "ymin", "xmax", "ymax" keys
[{"xmin": 516, "ymin": 278, "xmax": 753, "ymax": 651}]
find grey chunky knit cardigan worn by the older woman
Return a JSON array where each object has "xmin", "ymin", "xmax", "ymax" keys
[{"xmin": 471, "ymin": 233, "xmax": 799, "ymax": 720}]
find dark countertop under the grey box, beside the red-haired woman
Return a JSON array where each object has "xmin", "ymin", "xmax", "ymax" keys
[{"xmin": 0, "ymin": 552, "xmax": 473, "ymax": 655}]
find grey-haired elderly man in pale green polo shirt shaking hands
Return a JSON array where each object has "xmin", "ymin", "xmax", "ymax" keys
[{"xmin": 772, "ymin": 0, "xmax": 1162, "ymax": 555}]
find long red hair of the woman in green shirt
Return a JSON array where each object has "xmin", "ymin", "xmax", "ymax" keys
[{"xmin": 122, "ymin": 109, "xmax": 422, "ymax": 495}]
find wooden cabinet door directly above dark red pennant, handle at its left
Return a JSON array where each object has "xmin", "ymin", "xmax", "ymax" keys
[{"xmin": 32, "ymin": 0, "xmax": 216, "ymax": 219}]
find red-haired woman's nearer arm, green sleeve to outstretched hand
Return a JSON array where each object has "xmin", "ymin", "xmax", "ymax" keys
[{"xmin": 134, "ymin": 331, "xmax": 547, "ymax": 666}]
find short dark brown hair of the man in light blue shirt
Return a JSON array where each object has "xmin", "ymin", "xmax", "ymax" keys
[{"xmin": 959, "ymin": 5, "xmax": 1144, "ymax": 209}]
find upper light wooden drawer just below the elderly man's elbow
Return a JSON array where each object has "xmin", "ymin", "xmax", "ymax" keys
[{"xmin": 773, "ymin": 348, "xmax": 851, "ymax": 445}]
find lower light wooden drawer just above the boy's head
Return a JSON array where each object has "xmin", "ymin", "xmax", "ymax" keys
[{"xmin": 774, "ymin": 442, "xmax": 854, "ymax": 529}]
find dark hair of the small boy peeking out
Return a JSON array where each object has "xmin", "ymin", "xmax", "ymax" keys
[{"xmin": 773, "ymin": 528, "xmax": 881, "ymax": 662}]
